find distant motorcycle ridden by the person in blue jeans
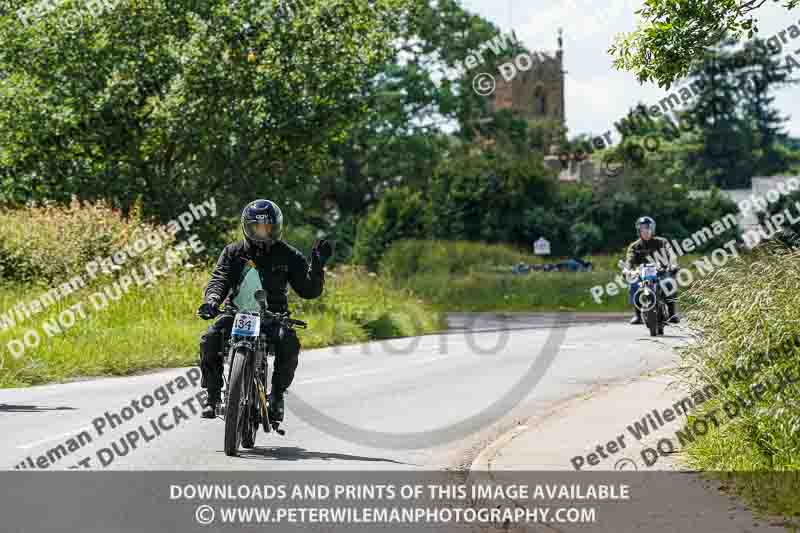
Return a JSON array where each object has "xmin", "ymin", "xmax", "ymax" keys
[{"xmin": 618, "ymin": 261, "xmax": 677, "ymax": 337}]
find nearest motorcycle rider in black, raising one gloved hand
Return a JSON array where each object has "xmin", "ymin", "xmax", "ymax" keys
[{"xmin": 197, "ymin": 200, "xmax": 333, "ymax": 422}]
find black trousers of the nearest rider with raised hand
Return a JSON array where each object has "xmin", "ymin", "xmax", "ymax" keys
[{"xmin": 200, "ymin": 315, "xmax": 300, "ymax": 402}]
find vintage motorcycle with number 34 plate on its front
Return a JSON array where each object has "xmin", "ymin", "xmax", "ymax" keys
[{"xmin": 220, "ymin": 290, "xmax": 308, "ymax": 456}]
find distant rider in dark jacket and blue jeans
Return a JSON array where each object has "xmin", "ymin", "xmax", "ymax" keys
[{"xmin": 625, "ymin": 216, "xmax": 680, "ymax": 324}]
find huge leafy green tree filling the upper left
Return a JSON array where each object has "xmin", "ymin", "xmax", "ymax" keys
[{"xmin": 0, "ymin": 0, "xmax": 406, "ymax": 224}]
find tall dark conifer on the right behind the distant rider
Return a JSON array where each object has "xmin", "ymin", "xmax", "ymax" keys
[{"xmin": 604, "ymin": 39, "xmax": 798, "ymax": 189}]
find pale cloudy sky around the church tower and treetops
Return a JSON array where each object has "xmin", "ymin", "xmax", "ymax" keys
[{"xmin": 461, "ymin": 0, "xmax": 800, "ymax": 138}]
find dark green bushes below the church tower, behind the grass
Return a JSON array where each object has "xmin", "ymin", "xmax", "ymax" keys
[{"xmin": 354, "ymin": 136, "xmax": 737, "ymax": 268}]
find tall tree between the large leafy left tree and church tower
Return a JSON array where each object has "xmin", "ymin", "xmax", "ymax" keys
[{"xmin": 312, "ymin": 0, "xmax": 512, "ymax": 220}]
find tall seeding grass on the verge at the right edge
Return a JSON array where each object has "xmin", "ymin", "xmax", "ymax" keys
[{"xmin": 681, "ymin": 246, "xmax": 800, "ymax": 527}]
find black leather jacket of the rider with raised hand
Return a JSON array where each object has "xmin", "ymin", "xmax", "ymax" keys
[{"xmin": 205, "ymin": 241, "xmax": 325, "ymax": 312}]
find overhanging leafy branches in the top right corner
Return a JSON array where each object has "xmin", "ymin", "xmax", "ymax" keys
[{"xmin": 609, "ymin": 0, "xmax": 800, "ymax": 87}]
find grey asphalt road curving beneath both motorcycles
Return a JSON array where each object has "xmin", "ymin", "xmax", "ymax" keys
[{"xmin": 0, "ymin": 315, "xmax": 686, "ymax": 470}]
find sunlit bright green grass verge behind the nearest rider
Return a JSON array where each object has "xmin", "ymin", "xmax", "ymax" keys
[{"xmin": 0, "ymin": 269, "xmax": 443, "ymax": 387}]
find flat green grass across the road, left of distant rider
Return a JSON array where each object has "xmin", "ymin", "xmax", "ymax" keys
[{"xmin": 380, "ymin": 240, "xmax": 698, "ymax": 312}]
